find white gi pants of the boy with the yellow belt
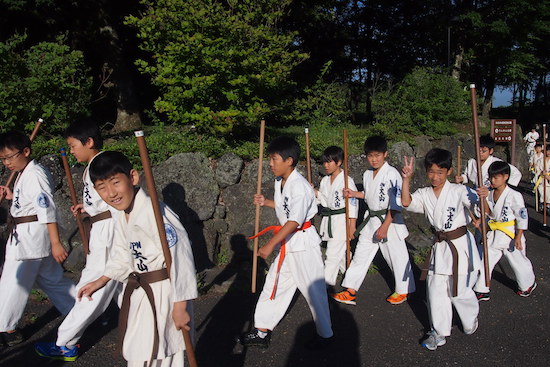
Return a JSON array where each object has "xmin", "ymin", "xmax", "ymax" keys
[{"xmin": 474, "ymin": 244, "xmax": 535, "ymax": 293}]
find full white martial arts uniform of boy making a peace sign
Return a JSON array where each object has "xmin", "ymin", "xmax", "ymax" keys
[{"xmin": 406, "ymin": 182, "xmax": 480, "ymax": 336}]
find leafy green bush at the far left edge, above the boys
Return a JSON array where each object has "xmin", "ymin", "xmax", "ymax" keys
[{"xmin": 0, "ymin": 36, "xmax": 92, "ymax": 134}]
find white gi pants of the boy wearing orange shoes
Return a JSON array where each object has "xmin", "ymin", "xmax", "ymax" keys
[{"xmin": 342, "ymin": 229, "xmax": 416, "ymax": 294}]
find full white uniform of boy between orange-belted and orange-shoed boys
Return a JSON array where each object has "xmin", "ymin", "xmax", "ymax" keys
[{"xmin": 317, "ymin": 171, "xmax": 359, "ymax": 285}]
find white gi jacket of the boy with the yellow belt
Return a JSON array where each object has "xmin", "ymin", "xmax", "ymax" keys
[{"xmin": 487, "ymin": 186, "xmax": 529, "ymax": 249}]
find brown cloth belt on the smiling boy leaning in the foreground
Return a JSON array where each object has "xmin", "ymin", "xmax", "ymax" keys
[{"xmin": 118, "ymin": 268, "xmax": 169, "ymax": 363}]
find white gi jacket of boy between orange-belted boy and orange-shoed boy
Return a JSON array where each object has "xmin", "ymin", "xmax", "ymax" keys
[{"xmin": 317, "ymin": 171, "xmax": 359, "ymax": 241}]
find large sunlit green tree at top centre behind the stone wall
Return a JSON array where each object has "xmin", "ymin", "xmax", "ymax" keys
[{"xmin": 127, "ymin": 0, "xmax": 307, "ymax": 134}]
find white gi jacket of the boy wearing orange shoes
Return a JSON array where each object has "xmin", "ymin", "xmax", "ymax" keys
[{"xmin": 361, "ymin": 162, "xmax": 409, "ymax": 240}]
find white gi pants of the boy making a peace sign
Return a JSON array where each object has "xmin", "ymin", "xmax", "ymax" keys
[{"xmin": 426, "ymin": 273, "xmax": 479, "ymax": 336}]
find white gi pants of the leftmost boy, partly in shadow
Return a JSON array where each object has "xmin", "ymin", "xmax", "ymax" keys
[{"xmin": 0, "ymin": 255, "xmax": 76, "ymax": 332}]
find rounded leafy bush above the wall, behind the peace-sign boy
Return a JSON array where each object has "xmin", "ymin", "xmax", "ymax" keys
[{"xmin": 372, "ymin": 68, "xmax": 470, "ymax": 141}]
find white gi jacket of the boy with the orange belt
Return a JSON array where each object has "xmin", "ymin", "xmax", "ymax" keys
[{"xmin": 273, "ymin": 169, "xmax": 321, "ymax": 252}]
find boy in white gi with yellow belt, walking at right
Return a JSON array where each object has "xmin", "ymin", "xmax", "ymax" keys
[{"xmin": 474, "ymin": 162, "xmax": 537, "ymax": 301}]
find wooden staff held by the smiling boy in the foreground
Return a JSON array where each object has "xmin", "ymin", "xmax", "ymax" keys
[{"xmin": 134, "ymin": 131, "xmax": 197, "ymax": 367}]
